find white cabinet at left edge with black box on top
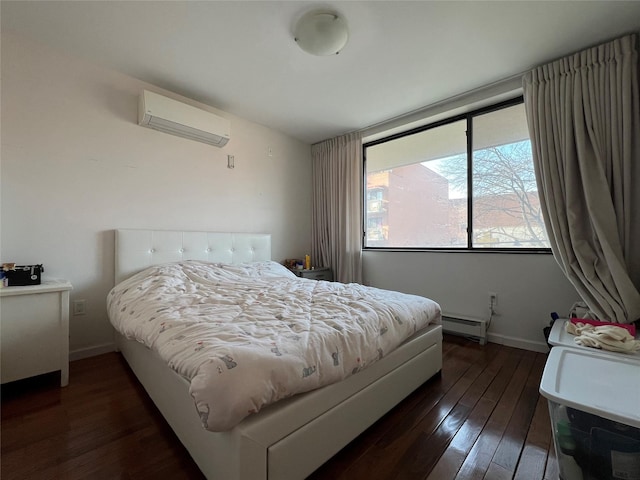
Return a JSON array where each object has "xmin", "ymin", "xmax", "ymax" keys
[{"xmin": 0, "ymin": 280, "xmax": 72, "ymax": 387}]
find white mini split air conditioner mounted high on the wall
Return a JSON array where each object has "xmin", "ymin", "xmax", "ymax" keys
[{"xmin": 138, "ymin": 90, "xmax": 231, "ymax": 147}]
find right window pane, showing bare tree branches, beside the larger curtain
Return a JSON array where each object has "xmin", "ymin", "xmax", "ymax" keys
[{"xmin": 472, "ymin": 104, "xmax": 549, "ymax": 248}]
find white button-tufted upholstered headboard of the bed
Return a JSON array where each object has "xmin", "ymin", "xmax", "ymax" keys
[{"xmin": 115, "ymin": 229, "xmax": 271, "ymax": 284}]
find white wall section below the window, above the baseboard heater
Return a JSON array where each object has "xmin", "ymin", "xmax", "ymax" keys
[{"xmin": 362, "ymin": 251, "xmax": 579, "ymax": 352}]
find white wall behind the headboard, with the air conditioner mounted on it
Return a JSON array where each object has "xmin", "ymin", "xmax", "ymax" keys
[{"xmin": 0, "ymin": 31, "xmax": 311, "ymax": 357}]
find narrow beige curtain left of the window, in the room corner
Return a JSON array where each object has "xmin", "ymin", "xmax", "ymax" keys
[{"xmin": 311, "ymin": 133, "xmax": 363, "ymax": 283}]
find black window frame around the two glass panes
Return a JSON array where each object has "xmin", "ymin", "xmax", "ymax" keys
[{"xmin": 361, "ymin": 95, "xmax": 552, "ymax": 254}]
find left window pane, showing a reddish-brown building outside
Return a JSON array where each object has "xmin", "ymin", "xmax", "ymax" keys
[{"xmin": 365, "ymin": 120, "xmax": 467, "ymax": 248}]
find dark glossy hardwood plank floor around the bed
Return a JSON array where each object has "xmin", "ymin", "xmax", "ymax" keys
[{"xmin": 0, "ymin": 336, "xmax": 558, "ymax": 480}]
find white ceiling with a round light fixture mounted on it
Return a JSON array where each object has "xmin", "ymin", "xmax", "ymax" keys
[{"xmin": 1, "ymin": 0, "xmax": 640, "ymax": 143}]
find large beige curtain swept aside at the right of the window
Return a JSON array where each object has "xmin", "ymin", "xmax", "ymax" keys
[{"xmin": 523, "ymin": 34, "xmax": 640, "ymax": 323}]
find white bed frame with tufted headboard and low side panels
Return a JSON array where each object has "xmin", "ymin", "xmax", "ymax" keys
[{"xmin": 115, "ymin": 230, "xmax": 442, "ymax": 480}]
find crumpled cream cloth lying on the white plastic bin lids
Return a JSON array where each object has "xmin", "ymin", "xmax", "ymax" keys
[{"xmin": 565, "ymin": 322, "xmax": 640, "ymax": 353}]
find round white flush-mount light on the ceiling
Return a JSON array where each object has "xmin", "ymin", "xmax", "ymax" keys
[{"xmin": 294, "ymin": 10, "xmax": 349, "ymax": 55}]
